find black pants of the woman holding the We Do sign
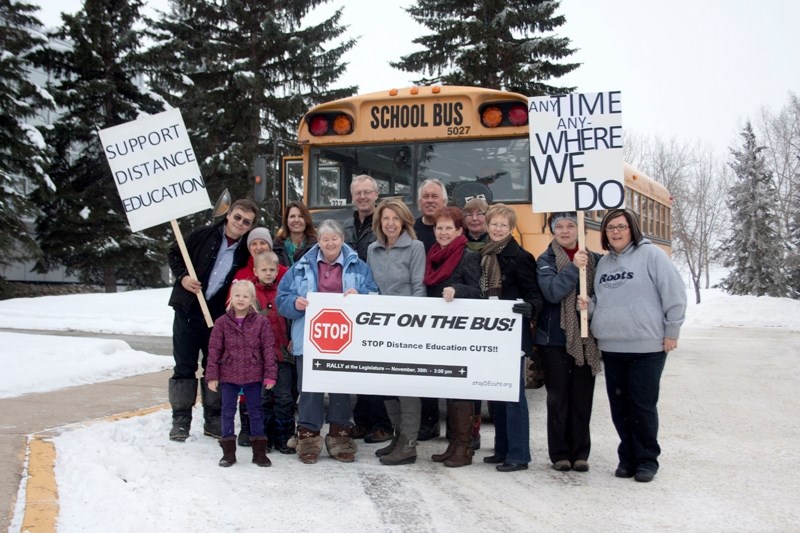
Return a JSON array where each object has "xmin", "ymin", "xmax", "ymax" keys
[{"xmin": 538, "ymin": 346, "xmax": 595, "ymax": 463}]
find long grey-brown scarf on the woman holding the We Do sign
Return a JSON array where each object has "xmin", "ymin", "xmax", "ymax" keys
[{"xmin": 550, "ymin": 241, "xmax": 601, "ymax": 376}]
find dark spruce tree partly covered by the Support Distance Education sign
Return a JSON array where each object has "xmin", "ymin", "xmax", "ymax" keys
[{"xmin": 36, "ymin": 0, "xmax": 166, "ymax": 292}]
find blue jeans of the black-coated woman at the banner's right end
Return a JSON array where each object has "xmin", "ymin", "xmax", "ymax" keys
[{"xmin": 489, "ymin": 357, "xmax": 531, "ymax": 463}]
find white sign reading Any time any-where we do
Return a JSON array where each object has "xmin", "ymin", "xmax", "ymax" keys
[{"xmin": 528, "ymin": 91, "xmax": 625, "ymax": 213}]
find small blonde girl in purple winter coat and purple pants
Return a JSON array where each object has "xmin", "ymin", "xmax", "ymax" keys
[{"xmin": 205, "ymin": 280, "xmax": 278, "ymax": 466}]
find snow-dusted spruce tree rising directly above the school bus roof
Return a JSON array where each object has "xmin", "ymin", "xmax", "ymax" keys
[{"xmin": 391, "ymin": 0, "xmax": 578, "ymax": 96}]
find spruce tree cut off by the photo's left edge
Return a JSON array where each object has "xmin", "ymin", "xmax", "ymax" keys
[{"xmin": 0, "ymin": 0, "xmax": 53, "ymax": 272}]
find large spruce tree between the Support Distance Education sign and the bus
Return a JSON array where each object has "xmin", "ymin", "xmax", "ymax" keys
[{"xmin": 146, "ymin": 0, "xmax": 355, "ymax": 227}]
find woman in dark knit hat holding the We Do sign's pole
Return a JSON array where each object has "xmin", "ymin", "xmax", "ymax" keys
[{"xmin": 534, "ymin": 211, "xmax": 602, "ymax": 472}]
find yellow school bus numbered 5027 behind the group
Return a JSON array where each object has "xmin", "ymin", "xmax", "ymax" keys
[{"xmin": 282, "ymin": 86, "xmax": 671, "ymax": 256}]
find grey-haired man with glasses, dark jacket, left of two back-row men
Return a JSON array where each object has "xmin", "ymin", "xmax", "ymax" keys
[{"xmin": 342, "ymin": 174, "xmax": 392, "ymax": 442}]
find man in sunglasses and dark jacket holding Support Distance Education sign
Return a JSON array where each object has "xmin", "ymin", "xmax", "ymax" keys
[{"xmin": 168, "ymin": 200, "xmax": 258, "ymax": 442}]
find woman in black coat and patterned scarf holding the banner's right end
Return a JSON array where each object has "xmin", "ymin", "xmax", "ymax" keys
[{"xmin": 481, "ymin": 204, "xmax": 542, "ymax": 472}]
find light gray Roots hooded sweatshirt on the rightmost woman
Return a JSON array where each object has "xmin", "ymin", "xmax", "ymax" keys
[{"xmin": 590, "ymin": 239, "xmax": 686, "ymax": 353}]
